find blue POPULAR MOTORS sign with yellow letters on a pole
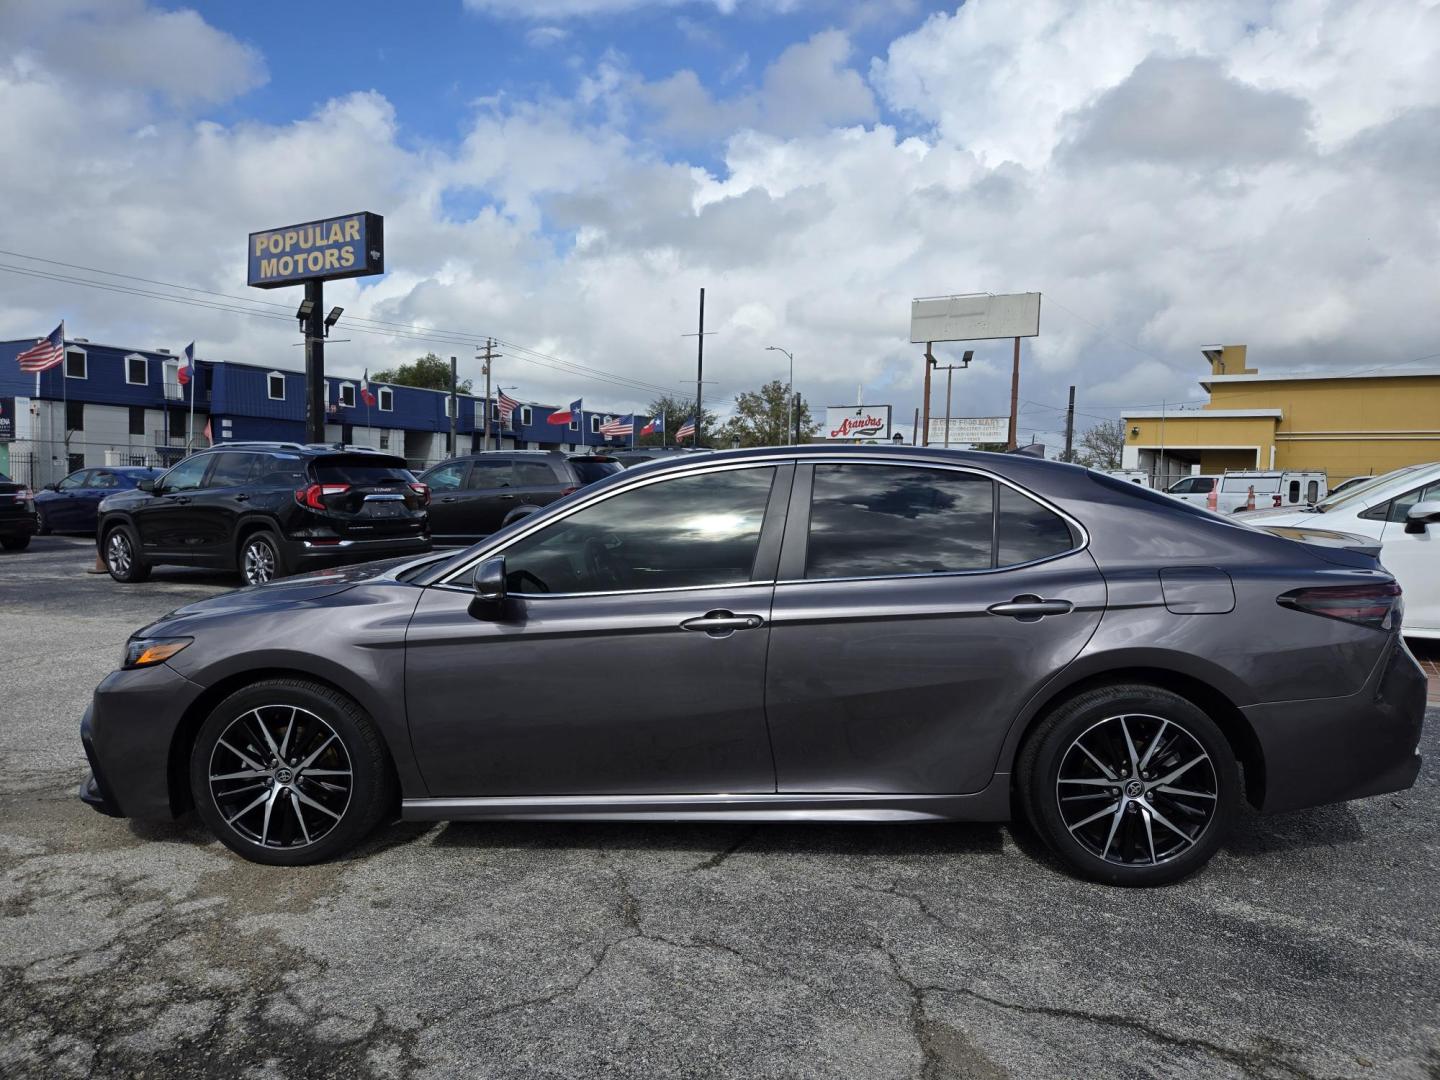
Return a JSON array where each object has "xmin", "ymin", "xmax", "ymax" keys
[{"xmin": 248, "ymin": 213, "xmax": 384, "ymax": 289}]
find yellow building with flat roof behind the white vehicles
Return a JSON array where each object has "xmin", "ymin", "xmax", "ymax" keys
[{"xmin": 1123, "ymin": 346, "xmax": 1440, "ymax": 487}]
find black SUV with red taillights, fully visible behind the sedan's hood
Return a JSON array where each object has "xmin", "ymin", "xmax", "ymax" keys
[{"xmin": 95, "ymin": 442, "xmax": 431, "ymax": 585}]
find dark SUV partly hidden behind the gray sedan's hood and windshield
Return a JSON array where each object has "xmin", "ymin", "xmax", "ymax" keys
[{"xmin": 420, "ymin": 451, "xmax": 624, "ymax": 544}]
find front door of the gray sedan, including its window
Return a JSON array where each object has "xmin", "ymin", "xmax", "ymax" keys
[{"xmin": 405, "ymin": 467, "xmax": 789, "ymax": 798}]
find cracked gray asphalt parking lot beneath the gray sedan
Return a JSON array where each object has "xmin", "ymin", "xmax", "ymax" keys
[{"xmin": 0, "ymin": 537, "xmax": 1440, "ymax": 1077}]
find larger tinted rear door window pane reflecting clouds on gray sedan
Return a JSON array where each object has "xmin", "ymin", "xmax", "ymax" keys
[{"xmin": 805, "ymin": 465, "xmax": 995, "ymax": 577}]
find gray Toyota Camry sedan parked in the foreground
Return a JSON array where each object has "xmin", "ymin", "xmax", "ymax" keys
[{"xmin": 81, "ymin": 446, "xmax": 1424, "ymax": 884}]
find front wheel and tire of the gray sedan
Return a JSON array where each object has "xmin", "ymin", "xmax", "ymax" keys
[{"xmin": 190, "ymin": 678, "xmax": 396, "ymax": 867}]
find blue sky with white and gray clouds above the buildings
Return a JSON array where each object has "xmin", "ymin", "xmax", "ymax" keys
[{"xmin": 0, "ymin": 0, "xmax": 1440, "ymax": 438}]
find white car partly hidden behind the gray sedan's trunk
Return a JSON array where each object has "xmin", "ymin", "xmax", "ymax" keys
[{"xmin": 1243, "ymin": 462, "xmax": 1440, "ymax": 639}]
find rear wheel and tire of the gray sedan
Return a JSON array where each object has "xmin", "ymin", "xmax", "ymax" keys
[{"xmin": 1017, "ymin": 684, "xmax": 1240, "ymax": 886}]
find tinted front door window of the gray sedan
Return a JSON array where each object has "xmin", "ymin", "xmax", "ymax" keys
[{"xmin": 504, "ymin": 467, "xmax": 775, "ymax": 593}]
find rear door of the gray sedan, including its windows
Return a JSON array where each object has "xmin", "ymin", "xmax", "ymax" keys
[{"xmin": 766, "ymin": 462, "xmax": 1104, "ymax": 793}]
